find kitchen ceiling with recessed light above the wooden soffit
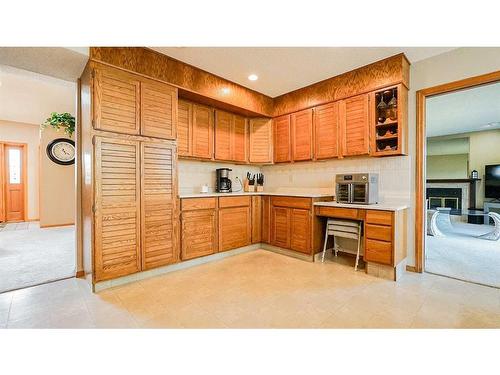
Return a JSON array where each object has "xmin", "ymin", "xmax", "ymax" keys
[{"xmin": 153, "ymin": 47, "xmax": 453, "ymax": 97}]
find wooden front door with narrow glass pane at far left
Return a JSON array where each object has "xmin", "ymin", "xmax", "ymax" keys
[{"xmin": 0, "ymin": 142, "xmax": 27, "ymax": 223}]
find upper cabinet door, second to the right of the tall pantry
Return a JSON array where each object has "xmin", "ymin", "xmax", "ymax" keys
[{"xmin": 193, "ymin": 104, "xmax": 214, "ymax": 159}]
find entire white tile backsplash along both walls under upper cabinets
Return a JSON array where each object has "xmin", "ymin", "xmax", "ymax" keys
[{"xmin": 178, "ymin": 156, "xmax": 412, "ymax": 201}]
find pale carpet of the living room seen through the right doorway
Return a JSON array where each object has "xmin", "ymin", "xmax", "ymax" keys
[{"xmin": 425, "ymin": 223, "xmax": 500, "ymax": 288}]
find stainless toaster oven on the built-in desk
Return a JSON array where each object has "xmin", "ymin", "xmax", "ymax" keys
[{"xmin": 335, "ymin": 173, "xmax": 378, "ymax": 204}]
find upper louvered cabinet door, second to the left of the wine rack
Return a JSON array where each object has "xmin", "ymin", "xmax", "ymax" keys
[{"xmin": 314, "ymin": 102, "xmax": 339, "ymax": 159}]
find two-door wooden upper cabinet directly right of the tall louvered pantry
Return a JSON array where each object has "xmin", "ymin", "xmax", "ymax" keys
[{"xmin": 177, "ymin": 100, "xmax": 214, "ymax": 159}]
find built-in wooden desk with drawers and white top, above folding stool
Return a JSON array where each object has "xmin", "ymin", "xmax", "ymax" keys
[{"xmin": 314, "ymin": 202, "xmax": 408, "ymax": 280}]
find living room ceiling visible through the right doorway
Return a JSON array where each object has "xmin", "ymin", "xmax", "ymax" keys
[{"xmin": 425, "ymin": 83, "xmax": 500, "ymax": 137}]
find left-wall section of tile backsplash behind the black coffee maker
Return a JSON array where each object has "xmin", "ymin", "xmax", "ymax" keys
[{"xmin": 178, "ymin": 160, "xmax": 261, "ymax": 194}]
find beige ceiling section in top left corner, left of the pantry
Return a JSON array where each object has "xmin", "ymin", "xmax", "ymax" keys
[{"xmin": 0, "ymin": 47, "xmax": 89, "ymax": 82}]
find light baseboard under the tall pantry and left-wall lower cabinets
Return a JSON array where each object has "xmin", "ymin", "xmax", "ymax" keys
[{"xmin": 93, "ymin": 243, "xmax": 262, "ymax": 292}]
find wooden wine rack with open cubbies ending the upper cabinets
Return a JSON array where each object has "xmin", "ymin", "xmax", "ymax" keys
[{"xmin": 371, "ymin": 85, "xmax": 408, "ymax": 156}]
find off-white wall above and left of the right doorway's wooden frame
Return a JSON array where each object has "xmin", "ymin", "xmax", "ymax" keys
[{"xmin": 408, "ymin": 48, "xmax": 500, "ymax": 265}]
